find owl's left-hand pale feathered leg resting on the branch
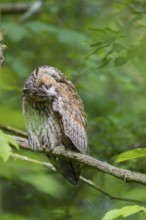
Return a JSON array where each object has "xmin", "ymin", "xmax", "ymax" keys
[{"xmin": 28, "ymin": 129, "xmax": 41, "ymax": 151}]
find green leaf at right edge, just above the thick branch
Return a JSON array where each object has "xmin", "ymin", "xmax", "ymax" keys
[{"xmin": 116, "ymin": 148, "xmax": 146, "ymax": 162}]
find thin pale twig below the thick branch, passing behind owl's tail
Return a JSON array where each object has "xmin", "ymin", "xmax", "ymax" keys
[{"xmin": 11, "ymin": 153, "xmax": 146, "ymax": 204}]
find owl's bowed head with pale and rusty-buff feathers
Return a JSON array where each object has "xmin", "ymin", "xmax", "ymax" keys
[{"xmin": 23, "ymin": 66, "xmax": 65, "ymax": 101}]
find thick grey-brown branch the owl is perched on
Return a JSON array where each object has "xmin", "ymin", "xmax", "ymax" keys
[{"xmin": 11, "ymin": 136, "xmax": 146, "ymax": 185}]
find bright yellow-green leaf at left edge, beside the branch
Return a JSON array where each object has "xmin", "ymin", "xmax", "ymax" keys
[{"xmin": 0, "ymin": 131, "xmax": 11, "ymax": 162}]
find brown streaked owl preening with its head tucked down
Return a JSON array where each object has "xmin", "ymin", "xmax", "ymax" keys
[{"xmin": 22, "ymin": 66, "xmax": 88, "ymax": 184}]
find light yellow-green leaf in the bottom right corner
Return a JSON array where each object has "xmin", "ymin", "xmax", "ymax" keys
[{"xmin": 102, "ymin": 205, "xmax": 146, "ymax": 220}]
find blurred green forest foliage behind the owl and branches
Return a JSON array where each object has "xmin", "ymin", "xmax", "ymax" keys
[{"xmin": 0, "ymin": 0, "xmax": 146, "ymax": 220}]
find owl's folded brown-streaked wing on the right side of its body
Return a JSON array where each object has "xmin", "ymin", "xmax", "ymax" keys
[{"xmin": 52, "ymin": 80, "xmax": 88, "ymax": 154}]
